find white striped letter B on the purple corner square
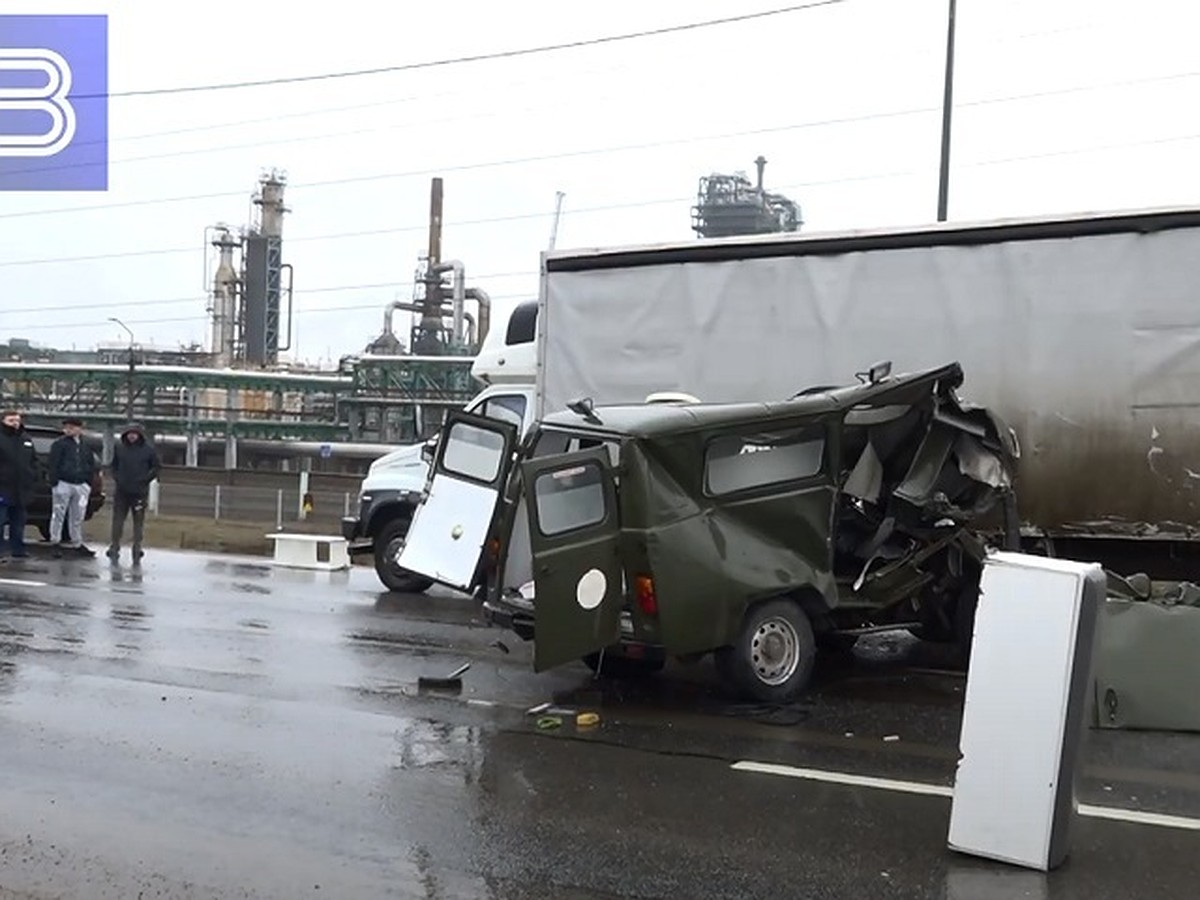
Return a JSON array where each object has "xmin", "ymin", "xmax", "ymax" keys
[{"xmin": 0, "ymin": 47, "xmax": 76, "ymax": 156}]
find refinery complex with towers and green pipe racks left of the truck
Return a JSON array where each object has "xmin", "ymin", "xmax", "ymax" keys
[{"xmin": 0, "ymin": 170, "xmax": 491, "ymax": 470}]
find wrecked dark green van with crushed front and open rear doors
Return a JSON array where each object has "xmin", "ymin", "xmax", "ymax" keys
[{"xmin": 397, "ymin": 364, "xmax": 1020, "ymax": 702}]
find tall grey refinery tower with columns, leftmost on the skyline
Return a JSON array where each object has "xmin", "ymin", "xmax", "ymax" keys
[{"xmin": 205, "ymin": 170, "xmax": 292, "ymax": 368}]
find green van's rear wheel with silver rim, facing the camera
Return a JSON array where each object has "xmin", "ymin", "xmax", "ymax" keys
[{"xmin": 715, "ymin": 598, "xmax": 817, "ymax": 703}]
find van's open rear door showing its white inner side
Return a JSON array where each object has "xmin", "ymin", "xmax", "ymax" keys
[{"xmin": 396, "ymin": 410, "xmax": 517, "ymax": 590}]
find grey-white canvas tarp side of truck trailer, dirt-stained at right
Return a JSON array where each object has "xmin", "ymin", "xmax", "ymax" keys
[{"xmin": 538, "ymin": 210, "xmax": 1200, "ymax": 528}]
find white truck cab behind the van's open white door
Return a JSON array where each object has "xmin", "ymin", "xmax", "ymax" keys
[{"xmin": 342, "ymin": 301, "xmax": 538, "ymax": 593}]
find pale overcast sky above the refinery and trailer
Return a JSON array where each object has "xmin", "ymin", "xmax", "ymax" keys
[{"xmin": 0, "ymin": 0, "xmax": 1200, "ymax": 361}]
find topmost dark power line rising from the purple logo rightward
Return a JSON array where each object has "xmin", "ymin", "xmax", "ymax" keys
[{"xmin": 88, "ymin": 0, "xmax": 844, "ymax": 98}]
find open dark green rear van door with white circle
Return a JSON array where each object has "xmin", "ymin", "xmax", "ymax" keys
[{"xmin": 521, "ymin": 448, "xmax": 624, "ymax": 672}]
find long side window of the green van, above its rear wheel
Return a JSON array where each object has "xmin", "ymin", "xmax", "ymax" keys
[{"xmin": 704, "ymin": 427, "xmax": 826, "ymax": 496}]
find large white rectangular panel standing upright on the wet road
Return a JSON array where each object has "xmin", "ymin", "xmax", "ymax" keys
[{"xmin": 948, "ymin": 553, "xmax": 1106, "ymax": 871}]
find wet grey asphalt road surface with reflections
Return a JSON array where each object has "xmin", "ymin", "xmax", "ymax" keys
[{"xmin": 0, "ymin": 553, "xmax": 1200, "ymax": 900}]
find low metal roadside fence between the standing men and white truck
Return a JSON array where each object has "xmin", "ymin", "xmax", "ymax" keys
[{"xmin": 148, "ymin": 482, "xmax": 356, "ymax": 528}]
